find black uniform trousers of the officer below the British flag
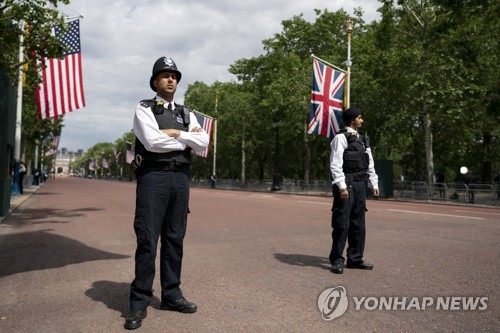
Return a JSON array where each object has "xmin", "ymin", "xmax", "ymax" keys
[{"xmin": 329, "ymin": 180, "xmax": 366, "ymax": 265}]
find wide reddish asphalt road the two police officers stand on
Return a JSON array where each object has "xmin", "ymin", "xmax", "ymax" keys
[{"xmin": 0, "ymin": 178, "xmax": 500, "ymax": 333}]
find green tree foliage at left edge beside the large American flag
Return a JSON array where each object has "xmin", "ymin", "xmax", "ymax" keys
[{"xmin": 0, "ymin": 0, "xmax": 69, "ymax": 170}]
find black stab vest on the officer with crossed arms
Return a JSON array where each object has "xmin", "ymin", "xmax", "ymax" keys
[{"xmin": 135, "ymin": 99, "xmax": 191, "ymax": 165}]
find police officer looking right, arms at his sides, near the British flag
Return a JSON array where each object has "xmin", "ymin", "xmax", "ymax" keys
[{"xmin": 329, "ymin": 107, "xmax": 379, "ymax": 274}]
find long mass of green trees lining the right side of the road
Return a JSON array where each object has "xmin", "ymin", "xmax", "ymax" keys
[{"xmin": 44, "ymin": 0, "xmax": 500, "ymax": 184}]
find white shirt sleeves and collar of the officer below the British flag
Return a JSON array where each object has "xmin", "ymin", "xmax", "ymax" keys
[{"xmin": 330, "ymin": 127, "xmax": 378, "ymax": 189}]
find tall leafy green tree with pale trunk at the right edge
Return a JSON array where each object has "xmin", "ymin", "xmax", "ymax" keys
[{"xmin": 372, "ymin": 0, "xmax": 498, "ymax": 182}]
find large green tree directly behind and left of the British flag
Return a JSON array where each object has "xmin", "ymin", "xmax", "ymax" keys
[{"xmin": 230, "ymin": 10, "xmax": 362, "ymax": 180}]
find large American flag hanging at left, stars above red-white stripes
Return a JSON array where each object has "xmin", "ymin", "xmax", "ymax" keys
[{"xmin": 36, "ymin": 20, "xmax": 85, "ymax": 119}]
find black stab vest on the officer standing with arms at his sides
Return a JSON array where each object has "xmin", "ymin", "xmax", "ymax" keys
[{"xmin": 340, "ymin": 129, "xmax": 370, "ymax": 176}]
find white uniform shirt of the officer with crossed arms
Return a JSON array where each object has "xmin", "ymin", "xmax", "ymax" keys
[{"xmin": 133, "ymin": 96, "xmax": 209, "ymax": 153}]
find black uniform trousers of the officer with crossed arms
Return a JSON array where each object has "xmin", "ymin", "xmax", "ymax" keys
[{"xmin": 130, "ymin": 169, "xmax": 189, "ymax": 310}]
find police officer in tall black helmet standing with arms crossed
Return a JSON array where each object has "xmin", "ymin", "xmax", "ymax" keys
[{"xmin": 124, "ymin": 57, "xmax": 208, "ymax": 329}]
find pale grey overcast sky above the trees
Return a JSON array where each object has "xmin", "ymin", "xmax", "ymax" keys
[{"xmin": 59, "ymin": 0, "xmax": 380, "ymax": 150}]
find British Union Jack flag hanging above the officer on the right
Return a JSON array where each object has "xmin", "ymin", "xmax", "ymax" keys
[{"xmin": 308, "ymin": 59, "xmax": 345, "ymax": 139}]
